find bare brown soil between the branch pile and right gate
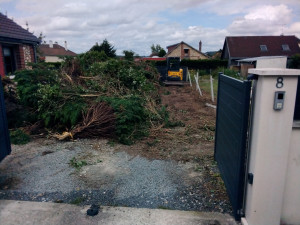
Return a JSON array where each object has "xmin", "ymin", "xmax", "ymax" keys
[{"xmin": 121, "ymin": 85, "xmax": 216, "ymax": 161}]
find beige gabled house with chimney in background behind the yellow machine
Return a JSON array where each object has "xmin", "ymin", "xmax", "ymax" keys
[{"xmin": 166, "ymin": 41, "xmax": 208, "ymax": 60}]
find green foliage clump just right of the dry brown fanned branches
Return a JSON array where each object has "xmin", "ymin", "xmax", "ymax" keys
[{"xmin": 101, "ymin": 95, "xmax": 149, "ymax": 145}]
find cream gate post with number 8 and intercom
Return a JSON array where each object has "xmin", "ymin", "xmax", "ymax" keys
[{"xmin": 242, "ymin": 68, "xmax": 300, "ymax": 225}]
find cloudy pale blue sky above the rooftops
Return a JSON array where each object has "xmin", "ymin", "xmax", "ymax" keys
[{"xmin": 0, "ymin": 0, "xmax": 300, "ymax": 56}]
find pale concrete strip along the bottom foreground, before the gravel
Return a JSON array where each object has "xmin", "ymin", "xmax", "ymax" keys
[{"xmin": 0, "ymin": 200, "xmax": 236, "ymax": 225}]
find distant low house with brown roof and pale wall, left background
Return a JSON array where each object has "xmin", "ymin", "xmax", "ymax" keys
[{"xmin": 38, "ymin": 41, "xmax": 77, "ymax": 62}]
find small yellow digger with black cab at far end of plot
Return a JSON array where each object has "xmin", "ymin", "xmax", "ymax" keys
[{"xmin": 167, "ymin": 57, "xmax": 183, "ymax": 81}]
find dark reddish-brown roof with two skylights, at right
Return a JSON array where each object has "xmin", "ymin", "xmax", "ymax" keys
[{"xmin": 222, "ymin": 35, "xmax": 300, "ymax": 58}]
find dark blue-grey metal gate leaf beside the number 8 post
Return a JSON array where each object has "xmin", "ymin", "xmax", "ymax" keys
[{"xmin": 215, "ymin": 74, "xmax": 251, "ymax": 220}]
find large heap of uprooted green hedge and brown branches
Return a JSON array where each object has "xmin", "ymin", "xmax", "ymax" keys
[{"xmin": 11, "ymin": 52, "xmax": 164, "ymax": 144}]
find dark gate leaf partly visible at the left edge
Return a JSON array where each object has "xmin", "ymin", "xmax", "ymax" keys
[{"xmin": 0, "ymin": 77, "xmax": 11, "ymax": 162}]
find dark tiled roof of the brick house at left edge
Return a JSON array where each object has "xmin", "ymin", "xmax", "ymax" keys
[{"xmin": 0, "ymin": 13, "xmax": 40, "ymax": 43}]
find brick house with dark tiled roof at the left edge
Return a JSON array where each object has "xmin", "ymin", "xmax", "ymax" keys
[{"xmin": 0, "ymin": 13, "xmax": 40, "ymax": 76}]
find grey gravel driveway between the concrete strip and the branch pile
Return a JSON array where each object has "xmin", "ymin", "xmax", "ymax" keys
[{"xmin": 0, "ymin": 139, "xmax": 231, "ymax": 213}]
